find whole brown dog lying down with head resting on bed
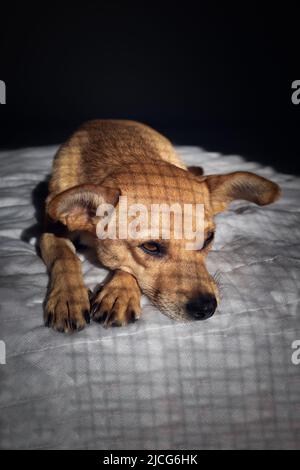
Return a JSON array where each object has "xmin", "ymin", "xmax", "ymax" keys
[{"xmin": 40, "ymin": 120, "xmax": 280, "ymax": 332}]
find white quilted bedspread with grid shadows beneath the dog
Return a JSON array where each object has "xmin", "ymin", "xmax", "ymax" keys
[{"xmin": 0, "ymin": 147, "xmax": 300, "ymax": 449}]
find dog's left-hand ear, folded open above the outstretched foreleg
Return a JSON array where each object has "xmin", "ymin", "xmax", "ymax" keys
[{"xmin": 47, "ymin": 184, "xmax": 121, "ymax": 233}]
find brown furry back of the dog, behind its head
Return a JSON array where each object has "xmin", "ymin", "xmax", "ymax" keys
[{"xmin": 49, "ymin": 120, "xmax": 186, "ymax": 198}]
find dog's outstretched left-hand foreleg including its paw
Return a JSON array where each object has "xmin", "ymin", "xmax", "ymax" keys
[{"xmin": 40, "ymin": 233, "xmax": 90, "ymax": 332}]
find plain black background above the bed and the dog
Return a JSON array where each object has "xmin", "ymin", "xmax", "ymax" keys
[{"xmin": 0, "ymin": 0, "xmax": 300, "ymax": 173}]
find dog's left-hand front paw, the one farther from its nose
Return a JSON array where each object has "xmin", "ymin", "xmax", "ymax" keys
[{"xmin": 45, "ymin": 287, "xmax": 90, "ymax": 333}]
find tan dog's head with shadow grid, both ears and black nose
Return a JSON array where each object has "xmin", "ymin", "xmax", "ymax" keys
[{"xmin": 48, "ymin": 163, "xmax": 280, "ymax": 321}]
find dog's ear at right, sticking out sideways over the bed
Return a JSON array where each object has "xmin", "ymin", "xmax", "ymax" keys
[{"xmin": 204, "ymin": 171, "xmax": 281, "ymax": 214}]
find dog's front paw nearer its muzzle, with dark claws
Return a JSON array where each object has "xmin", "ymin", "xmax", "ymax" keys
[{"xmin": 91, "ymin": 270, "xmax": 141, "ymax": 327}]
